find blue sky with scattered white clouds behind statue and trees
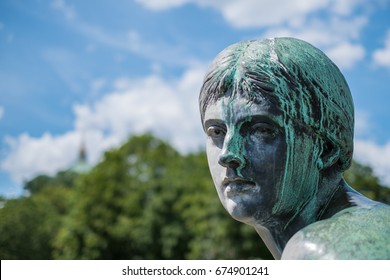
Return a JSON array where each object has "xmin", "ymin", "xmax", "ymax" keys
[{"xmin": 0, "ymin": 0, "xmax": 390, "ymax": 197}]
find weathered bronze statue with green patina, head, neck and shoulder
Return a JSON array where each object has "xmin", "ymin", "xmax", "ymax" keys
[{"xmin": 199, "ymin": 38, "xmax": 390, "ymax": 259}]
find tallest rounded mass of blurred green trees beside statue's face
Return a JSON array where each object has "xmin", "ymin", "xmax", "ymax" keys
[{"xmin": 56, "ymin": 135, "xmax": 269, "ymax": 259}]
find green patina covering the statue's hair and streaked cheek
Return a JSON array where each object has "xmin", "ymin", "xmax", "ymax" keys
[{"xmin": 200, "ymin": 38, "xmax": 354, "ymax": 227}]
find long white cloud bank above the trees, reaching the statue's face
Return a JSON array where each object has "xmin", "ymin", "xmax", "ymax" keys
[{"xmin": 0, "ymin": 66, "xmax": 205, "ymax": 182}]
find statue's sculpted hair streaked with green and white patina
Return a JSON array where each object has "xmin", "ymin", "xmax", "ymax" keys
[{"xmin": 199, "ymin": 38, "xmax": 354, "ymax": 171}]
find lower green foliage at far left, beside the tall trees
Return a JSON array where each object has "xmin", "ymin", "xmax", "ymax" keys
[{"xmin": 0, "ymin": 188, "xmax": 70, "ymax": 259}]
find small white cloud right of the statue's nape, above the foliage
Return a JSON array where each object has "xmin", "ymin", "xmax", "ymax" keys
[{"xmin": 354, "ymin": 140, "xmax": 390, "ymax": 186}]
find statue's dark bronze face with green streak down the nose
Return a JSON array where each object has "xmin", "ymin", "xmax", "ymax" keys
[{"xmin": 204, "ymin": 96, "xmax": 286, "ymax": 224}]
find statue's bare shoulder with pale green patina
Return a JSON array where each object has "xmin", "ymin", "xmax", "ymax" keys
[{"xmin": 282, "ymin": 204, "xmax": 390, "ymax": 259}]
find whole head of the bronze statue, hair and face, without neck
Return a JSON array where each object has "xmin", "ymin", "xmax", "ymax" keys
[{"xmin": 199, "ymin": 38, "xmax": 354, "ymax": 223}]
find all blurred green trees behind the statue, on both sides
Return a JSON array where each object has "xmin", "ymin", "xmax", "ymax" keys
[{"xmin": 0, "ymin": 135, "xmax": 389, "ymax": 259}]
